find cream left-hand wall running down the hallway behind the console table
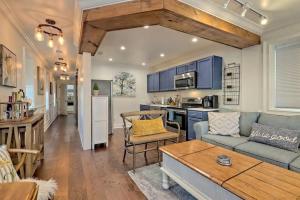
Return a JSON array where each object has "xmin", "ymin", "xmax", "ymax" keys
[{"xmin": 0, "ymin": 2, "xmax": 56, "ymax": 129}]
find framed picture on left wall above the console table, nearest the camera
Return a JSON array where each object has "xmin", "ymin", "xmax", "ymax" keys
[{"xmin": 0, "ymin": 44, "xmax": 17, "ymax": 87}]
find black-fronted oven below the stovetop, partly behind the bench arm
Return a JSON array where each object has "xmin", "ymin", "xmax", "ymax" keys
[{"xmin": 167, "ymin": 108, "xmax": 187, "ymax": 130}]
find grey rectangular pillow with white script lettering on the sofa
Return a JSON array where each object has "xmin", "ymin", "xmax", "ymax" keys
[{"xmin": 249, "ymin": 123, "xmax": 300, "ymax": 153}]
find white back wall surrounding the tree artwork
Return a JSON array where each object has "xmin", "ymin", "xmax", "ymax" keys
[{"xmin": 92, "ymin": 61, "xmax": 150, "ymax": 128}]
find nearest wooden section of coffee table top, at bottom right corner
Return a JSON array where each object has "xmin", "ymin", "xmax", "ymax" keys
[{"xmin": 223, "ymin": 163, "xmax": 300, "ymax": 200}]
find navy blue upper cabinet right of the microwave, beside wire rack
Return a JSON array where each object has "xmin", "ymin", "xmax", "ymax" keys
[{"xmin": 197, "ymin": 56, "xmax": 223, "ymax": 89}]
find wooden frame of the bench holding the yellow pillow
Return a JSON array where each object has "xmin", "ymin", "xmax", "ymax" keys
[{"xmin": 121, "ymin": 110, "xmax": 180, "ymax": 172}]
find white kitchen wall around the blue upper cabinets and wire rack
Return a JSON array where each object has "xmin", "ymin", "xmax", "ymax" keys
[{"xmin": 151, "ymin": 44, "xmax": 262, "ymax": 111}]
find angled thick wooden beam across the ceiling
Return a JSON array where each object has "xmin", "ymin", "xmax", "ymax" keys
[{"xmin": 79, "ymin": 0, "xmax": 260, "ymax": 55}]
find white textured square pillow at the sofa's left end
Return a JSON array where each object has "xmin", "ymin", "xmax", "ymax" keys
[{"xmin": 208, "ymin": 112, "xmax": 240, "ymax": 137}]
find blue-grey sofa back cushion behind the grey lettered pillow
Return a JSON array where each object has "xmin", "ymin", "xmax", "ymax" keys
[{"xmin": 258, "ymin": 113, "xmax": 300, "ymax": 130}]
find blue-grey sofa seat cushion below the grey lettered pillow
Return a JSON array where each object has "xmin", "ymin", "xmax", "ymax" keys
[{"xmin": 234, "ymin": 142, "xmax": 300, "ymax": 168}]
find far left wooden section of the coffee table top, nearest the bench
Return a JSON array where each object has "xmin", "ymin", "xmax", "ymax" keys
[{"xmin": 159, "ymin": 140, "xmax": 215, "ymax": 159}]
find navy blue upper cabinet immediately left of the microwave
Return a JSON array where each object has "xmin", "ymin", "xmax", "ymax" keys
[{"xmin": 159, "ymin": 68, "xmax": 176, "ymax": 91}]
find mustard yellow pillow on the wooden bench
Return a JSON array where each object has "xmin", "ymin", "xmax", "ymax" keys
[{"xmin": 132, "ymin": 117, "xmax": 167, "ymax": 136}]
